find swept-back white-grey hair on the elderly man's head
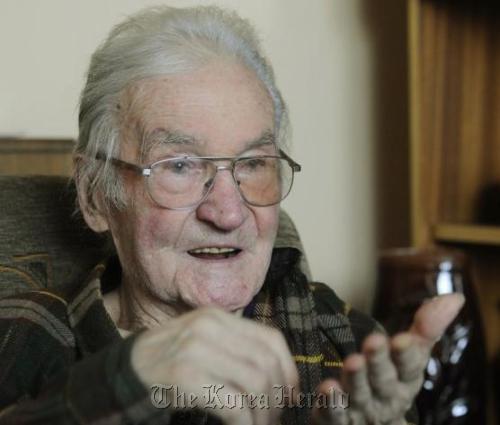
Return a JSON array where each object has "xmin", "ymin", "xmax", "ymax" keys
[{"xmin": 75, "ymin": 6, "xmax": 288, "ymax": 208}]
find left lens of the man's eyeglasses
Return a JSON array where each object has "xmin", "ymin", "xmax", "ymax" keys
[{"xmin": 148, "ymin": 158, "xmax": 215, "ymax": 208}]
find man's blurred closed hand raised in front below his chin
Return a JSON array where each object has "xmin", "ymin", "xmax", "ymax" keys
[{"xmin": 131, "ymin": 308, "xmax": 299, "ymax": 425}]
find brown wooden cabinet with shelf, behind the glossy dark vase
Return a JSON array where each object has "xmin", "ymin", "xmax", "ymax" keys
[{"xmin": 408, "ymin": 0, "xmax": 500, "ymax": 420}]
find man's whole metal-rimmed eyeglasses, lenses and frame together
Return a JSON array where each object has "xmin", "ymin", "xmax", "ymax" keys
[{"xmin": 96, "ymin": 150, "xmax": 301, "ymax": 210}]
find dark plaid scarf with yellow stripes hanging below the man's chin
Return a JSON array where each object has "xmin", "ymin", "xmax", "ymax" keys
[{"xmin": 244, "ymin": 249, "xmax": 346, "ymax": 425}]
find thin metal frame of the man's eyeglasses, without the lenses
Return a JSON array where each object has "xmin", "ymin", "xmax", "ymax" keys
[{"xmin": 95, "ymin": 149, "xmax": 302, "ymax": 211}]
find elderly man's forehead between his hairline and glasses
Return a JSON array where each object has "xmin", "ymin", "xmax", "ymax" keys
[{"xmin": 121, "ymin": 63, "xmax": 276, "ymax": 161}]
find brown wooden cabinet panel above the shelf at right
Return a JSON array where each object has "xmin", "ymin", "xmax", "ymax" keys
[{"xmin": 410, "ymin": 0, "xmax": 500, "ymax": 238}]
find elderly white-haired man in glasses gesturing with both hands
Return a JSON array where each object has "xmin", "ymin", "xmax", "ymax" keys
[{"xmin": 0, "ymin": 7, "xmax": 463, "ymax": 425}]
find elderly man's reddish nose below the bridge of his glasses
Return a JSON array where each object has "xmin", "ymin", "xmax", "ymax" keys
[{"xmin": 196, "ymin": 169, "xmax": 249, "ymax": 231}]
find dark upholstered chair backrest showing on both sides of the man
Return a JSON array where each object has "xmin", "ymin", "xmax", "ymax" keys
[{"xmin": 0, "ymin": 176, "xmax": 309, "ymax": 296}]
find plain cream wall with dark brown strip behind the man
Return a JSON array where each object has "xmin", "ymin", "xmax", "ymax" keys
[{"xmin": 0, "ymin": 0, "xmax": 408, "ymax": 310}]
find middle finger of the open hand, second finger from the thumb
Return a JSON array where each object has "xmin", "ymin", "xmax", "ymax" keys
[{"xmin": 363, "ymin": 334, "xmax": 398, "ymax": 399}]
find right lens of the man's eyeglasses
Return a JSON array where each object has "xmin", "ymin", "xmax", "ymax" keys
[{"xmin": 234, "ymin": 157, "xmax": 293, "ymax": 207}]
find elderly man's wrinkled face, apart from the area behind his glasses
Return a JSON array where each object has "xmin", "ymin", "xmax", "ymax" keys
[{"xmin": 108, "ymin": 62, "xmax": 279, "ymax": 311}]
